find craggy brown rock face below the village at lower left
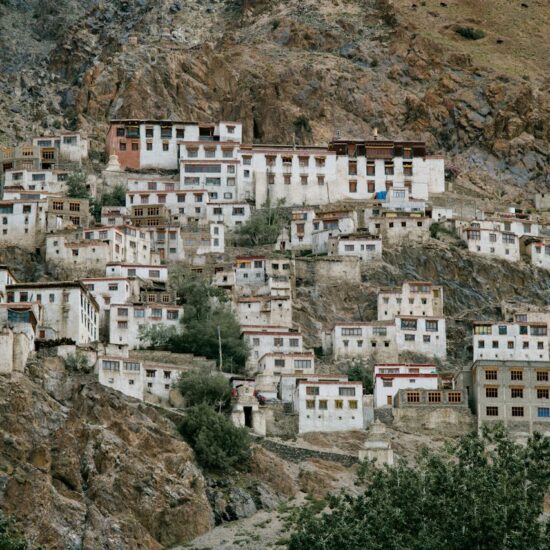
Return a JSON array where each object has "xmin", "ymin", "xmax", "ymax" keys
[{"xmin": 0, "ymin": 359, "xmax": 213, "ymax": 549}]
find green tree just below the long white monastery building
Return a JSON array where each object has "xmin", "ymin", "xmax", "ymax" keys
[{"xmin": 236, "ymin": 200, "xmax": 290, "ymax": 246}]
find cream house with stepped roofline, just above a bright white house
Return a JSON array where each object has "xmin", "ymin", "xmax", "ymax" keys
[{"xmin": 378, "ymin": 281, "xmax": 443, "ymax": 321}]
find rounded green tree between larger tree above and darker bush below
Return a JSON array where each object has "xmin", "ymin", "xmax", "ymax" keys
[{"xmin": 178, "ymin": 369, "xmax": 231, "ymax": 412}]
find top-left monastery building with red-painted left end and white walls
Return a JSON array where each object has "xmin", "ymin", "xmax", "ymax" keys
[{"xmin": 106, "ymin": 119, "xmax": 242, "ymax": 170}]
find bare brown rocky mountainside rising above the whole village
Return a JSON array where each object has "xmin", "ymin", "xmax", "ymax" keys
[{"xmin": 0, "ymin": 0, "xmax": 550, "ymax": 190}]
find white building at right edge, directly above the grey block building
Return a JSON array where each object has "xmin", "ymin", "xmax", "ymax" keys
[{"xmin": 473, "ymin": 322, "xmax": 550, "ymax": 361}]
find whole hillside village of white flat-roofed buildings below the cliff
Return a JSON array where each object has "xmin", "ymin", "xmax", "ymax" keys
[{"xmin": 0, "ymin": 119, "xmax": 550, "ymax": 450}]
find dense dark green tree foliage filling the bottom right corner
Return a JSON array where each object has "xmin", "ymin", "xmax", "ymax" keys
[{"xmin": 288, "ymin": 427, "xmax": 550, "ymax": 550}]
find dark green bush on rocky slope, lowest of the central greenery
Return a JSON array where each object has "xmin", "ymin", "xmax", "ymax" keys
[{"xmin": 180, "ymin": 403, "xmax": 250, "ymax": 472}]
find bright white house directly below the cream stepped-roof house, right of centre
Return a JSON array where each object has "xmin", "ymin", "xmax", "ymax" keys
[{"xmin": 395, "ymin": 315, "xmax": 447, "ymax": 359}]
